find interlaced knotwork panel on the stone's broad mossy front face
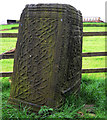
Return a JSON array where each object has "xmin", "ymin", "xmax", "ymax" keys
[{"xmin": 13, "ymin": 18, "xmax": 57, "ymax": 104}]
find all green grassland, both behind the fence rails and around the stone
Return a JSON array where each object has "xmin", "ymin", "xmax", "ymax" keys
[{"xmin": 0, "ymin": 23, "xmax": 107, "ymax": 119}]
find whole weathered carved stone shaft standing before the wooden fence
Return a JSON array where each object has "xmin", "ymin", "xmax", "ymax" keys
[{"xmin": 9, "ymin": 4, "xmax": 82, "ymax": 111}]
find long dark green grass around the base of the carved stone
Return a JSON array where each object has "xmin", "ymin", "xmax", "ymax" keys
[{"xmin": 1, "ymin": 74, "xmax": 106, "ymax": 119}]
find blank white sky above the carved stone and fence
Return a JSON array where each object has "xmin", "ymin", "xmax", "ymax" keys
[{"xmin": 0, "ymin": 0, "xmax": 107, "ymax": 24}]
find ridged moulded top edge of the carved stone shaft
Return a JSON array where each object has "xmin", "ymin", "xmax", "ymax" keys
[{"xmin": 23, "ymin": 4, "xmax": 82, "ymax": 18}]
